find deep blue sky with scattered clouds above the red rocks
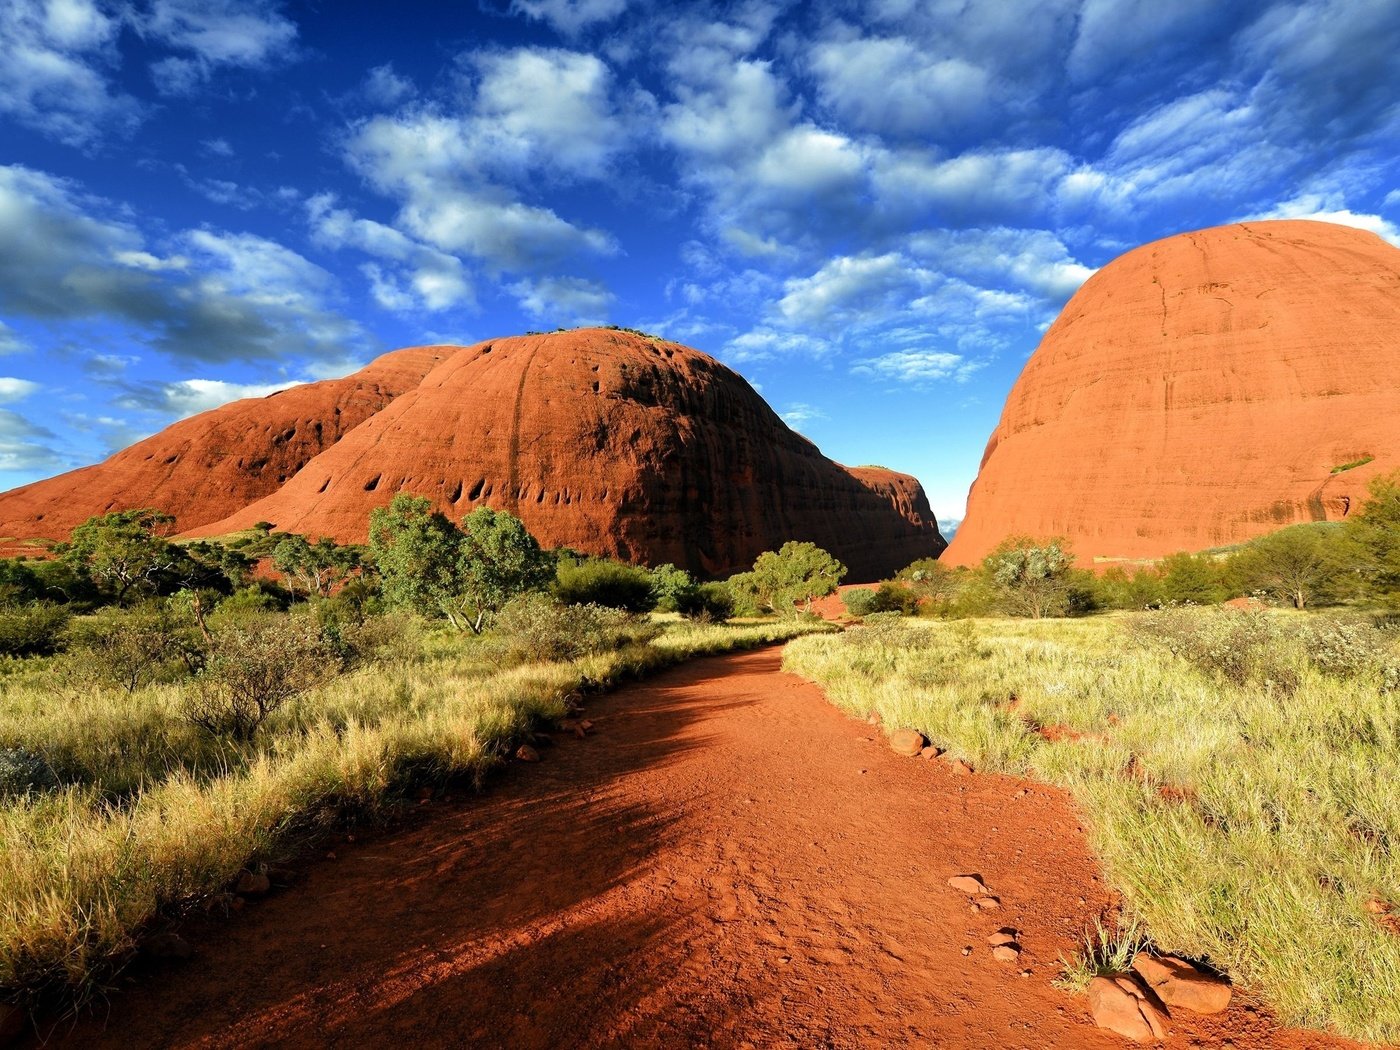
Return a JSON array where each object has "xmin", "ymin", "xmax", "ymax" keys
[{"xmin": 0, "ymin": 0, "xmax": 1400, "ymax": 526}]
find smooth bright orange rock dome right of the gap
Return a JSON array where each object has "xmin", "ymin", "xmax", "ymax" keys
[{"xmin": 945, "ymin": 220, "xmax": 1400, "ymax": 564}]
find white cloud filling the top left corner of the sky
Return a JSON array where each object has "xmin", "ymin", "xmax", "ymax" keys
[{"xmin": 0, "ymin": 0, "xmax": 141, "ymax": 147}]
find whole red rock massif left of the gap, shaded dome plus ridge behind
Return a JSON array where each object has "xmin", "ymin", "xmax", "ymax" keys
[{"xmin": 0, "ymin": 329, "xmax": 945, "ymax": 581}]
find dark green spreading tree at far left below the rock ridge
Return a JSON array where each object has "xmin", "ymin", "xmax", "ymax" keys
[{"xmin": 60, "ymin": 508, "xmax": 182, "ymax": 602}]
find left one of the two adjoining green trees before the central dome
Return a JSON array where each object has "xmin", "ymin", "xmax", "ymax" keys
[{"xmin": 370, "ymin": 493, "xmax": 462, "ymax": 629}]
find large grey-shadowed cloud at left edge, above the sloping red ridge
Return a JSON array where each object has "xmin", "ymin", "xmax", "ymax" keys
[{"xmin": 0, "ymin": 165, "xmax": 364, "ymax": 361}]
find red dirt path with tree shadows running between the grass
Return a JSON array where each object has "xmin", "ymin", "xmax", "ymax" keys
[{"xmin": 40, "ymin": 648, "xmax": 1355, "ymax": 1050}]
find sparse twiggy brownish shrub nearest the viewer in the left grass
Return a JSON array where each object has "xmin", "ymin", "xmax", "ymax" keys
[{"xmin": 185, "ymin": 613, "xmax": 339, "ymax": 742}]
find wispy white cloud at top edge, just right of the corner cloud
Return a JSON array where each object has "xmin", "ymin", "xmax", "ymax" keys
[{"xmin": 136, "ymin": 0, "xmax": 297, "ymax": 95}]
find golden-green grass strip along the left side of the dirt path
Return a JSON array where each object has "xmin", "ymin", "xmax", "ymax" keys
[{"xmin": 0, "ymin": 620, "xmax": 827, "ymax": 1001}]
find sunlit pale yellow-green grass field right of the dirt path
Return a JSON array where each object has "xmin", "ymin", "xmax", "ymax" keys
[{"xmin": 785, "ymin": 612, "xmax": 1400, "ymax": 1040}]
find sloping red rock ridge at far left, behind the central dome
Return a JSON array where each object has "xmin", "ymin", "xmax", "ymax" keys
[{"xmin": 0, "ymin": 346, "xmax": 452, "ymax": 539}]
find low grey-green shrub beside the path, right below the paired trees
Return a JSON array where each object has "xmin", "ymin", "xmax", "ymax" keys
[{"xmin": 494, "ymin": 594, "xmax": 661, "ymax": 664}]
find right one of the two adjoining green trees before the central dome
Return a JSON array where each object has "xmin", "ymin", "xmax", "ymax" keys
[{"xmin": 458, "ymin": 507, "xmax": 554, "ymax": 633}]
